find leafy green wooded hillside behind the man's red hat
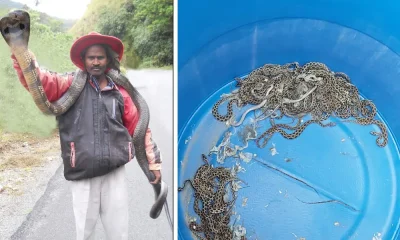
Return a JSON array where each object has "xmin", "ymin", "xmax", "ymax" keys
[{"xmin": 69, "ymin": 0, "xmax": 173, "ymax": 68}]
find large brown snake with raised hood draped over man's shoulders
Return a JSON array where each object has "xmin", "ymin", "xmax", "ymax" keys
[{"xmin": 0, "ymin": 10, "xmax": 172, "ymax": 228}]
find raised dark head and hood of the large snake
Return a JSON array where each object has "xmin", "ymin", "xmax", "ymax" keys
[{"xmin": 0, "ymin": 10, "xmax": 30, "ymax": 47}]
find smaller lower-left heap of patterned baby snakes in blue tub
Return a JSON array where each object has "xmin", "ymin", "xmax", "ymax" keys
[{"xmin": 178, "ymin": 154, "xmax": 244, "ymax": 240}]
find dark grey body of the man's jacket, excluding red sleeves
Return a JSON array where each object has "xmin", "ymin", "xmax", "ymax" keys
[{"xmin": 58, "ymin": 79, "xmax": 134, "ymax": 180}]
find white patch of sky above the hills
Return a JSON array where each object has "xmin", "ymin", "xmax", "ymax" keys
[{"xmin": 12, "ymin": 0, "xmax": 91, "ymax": 19}]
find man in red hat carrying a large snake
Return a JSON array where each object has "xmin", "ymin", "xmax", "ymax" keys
[{"xmin": 11, "ymin": 32, "xmax": 161, "ymax": 240}]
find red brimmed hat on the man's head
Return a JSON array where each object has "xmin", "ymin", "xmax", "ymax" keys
[{"xmin": 70, "ymin": 32, "xmax": 124, "ymax": 70}]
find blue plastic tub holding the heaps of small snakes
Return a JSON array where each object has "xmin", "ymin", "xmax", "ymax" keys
[{"xmin": 178, "ymin": 0, "xmax": 400, "ymax": 240}]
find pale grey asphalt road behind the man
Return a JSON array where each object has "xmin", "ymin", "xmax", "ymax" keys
[{"xmin": 11, "ymin": 70, "xmax": 174, "ymax": 240}]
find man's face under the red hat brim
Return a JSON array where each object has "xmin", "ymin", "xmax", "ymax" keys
[{"xmin": 84, "ymin": 45, "xmax": 108, "ymax": 77}]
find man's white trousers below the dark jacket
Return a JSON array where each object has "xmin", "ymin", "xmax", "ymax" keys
[{"xmin": 71, "ymin": 166, "xmax": 129, "ymax": 240}]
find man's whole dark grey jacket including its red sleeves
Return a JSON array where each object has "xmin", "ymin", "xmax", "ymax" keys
[{"xmin": 11, "ymin": 54, "xmax": 162, "ymax": 180}]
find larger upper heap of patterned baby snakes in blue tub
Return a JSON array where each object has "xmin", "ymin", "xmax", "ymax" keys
[{"xmin": 212, "ymin": 62, "xmax": 388, "ymax": 148}]
